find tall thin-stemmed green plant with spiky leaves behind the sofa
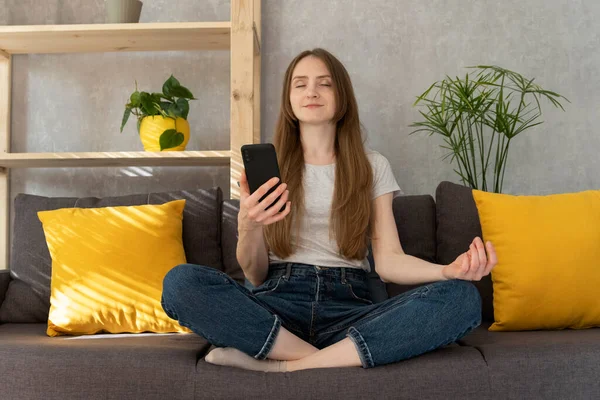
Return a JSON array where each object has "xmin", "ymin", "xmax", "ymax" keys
[{"xmin": 410, "ymin": 65, "xmax": 570, "ymax": 193}]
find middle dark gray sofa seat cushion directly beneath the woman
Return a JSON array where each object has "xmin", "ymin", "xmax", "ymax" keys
[{"xmin": 195, "ymin": 343, "xmax": 489, "ymax": 400}]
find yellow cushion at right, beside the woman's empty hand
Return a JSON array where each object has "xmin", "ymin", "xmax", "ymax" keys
[{"xmin": 473, "ymin": 190, "xmax": 600, "ymax": 331}]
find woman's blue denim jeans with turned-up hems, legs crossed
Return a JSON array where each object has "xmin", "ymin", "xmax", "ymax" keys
[{"xmin": 161, "ymin": 263, "xmax": 481, "ymax": 368}]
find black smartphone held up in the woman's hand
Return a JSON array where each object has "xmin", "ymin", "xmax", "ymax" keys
[{"xmin": 241, "ymin": 143, "xmax": 285, "ymax": 212}]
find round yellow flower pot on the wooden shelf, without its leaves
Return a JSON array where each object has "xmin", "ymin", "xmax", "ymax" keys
[{"xmin": 140, "ymin": 115, "xmax": 190, "ymax": 151}]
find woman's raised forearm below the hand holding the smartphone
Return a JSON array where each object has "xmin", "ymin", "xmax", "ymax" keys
[{"xmin": 236, "ymin": 227, "xmax": 269, "ymax": 286}]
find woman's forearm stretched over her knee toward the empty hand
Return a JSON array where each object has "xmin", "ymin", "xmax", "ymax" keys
[{"xmin": 375, "ymin": 253, "xmax": 447, "ymax": 285}]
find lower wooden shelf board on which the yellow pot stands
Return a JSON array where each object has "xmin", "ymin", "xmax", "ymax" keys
[{"xmin": 0, "ymin": 150, "xmax": 231, "ymax": 168}]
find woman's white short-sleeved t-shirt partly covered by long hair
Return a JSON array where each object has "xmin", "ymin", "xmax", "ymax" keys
[{"xmin": 269, "ymin": 150, "xmax": 403, "ymax": 272}]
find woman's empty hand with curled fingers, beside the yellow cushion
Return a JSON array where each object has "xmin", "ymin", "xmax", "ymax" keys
[{"xmin": 442, "ymin": 236, "xmax": 498, "ymax": 281}]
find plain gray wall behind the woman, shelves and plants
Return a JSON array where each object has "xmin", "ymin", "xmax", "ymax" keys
[{"xmin": 0, "ymin": 0, "xmax": 600, "ymax": 209}]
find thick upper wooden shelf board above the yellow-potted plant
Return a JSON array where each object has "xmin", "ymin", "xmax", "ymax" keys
[{"xmin": 0, "ymin": 21, "xmax": 231, "ymax": 54}]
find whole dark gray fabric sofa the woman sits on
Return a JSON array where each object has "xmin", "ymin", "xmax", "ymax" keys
[{"xmin": 0, "ymin": 182, "xmax": 600, "ymax": 399}]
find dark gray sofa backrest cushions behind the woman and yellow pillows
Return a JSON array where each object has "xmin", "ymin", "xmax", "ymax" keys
[{"xmin": 0, "ymin": 182, "xmax": 494, "ymax": 322}]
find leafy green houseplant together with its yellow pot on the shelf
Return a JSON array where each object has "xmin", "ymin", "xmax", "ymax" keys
[{"xmin": 121, "ymin": 75, "xmax": 196, "ymax": 151}]
